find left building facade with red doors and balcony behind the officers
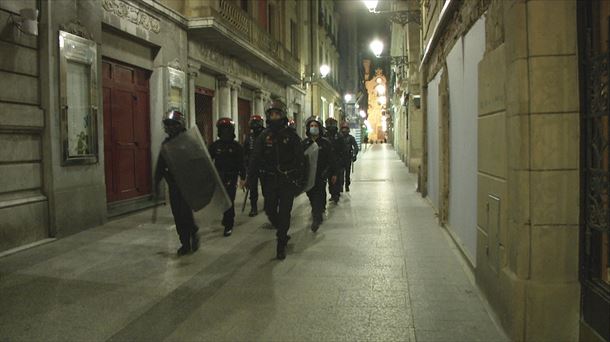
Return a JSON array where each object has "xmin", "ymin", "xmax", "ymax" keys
[{"xmin": 0, "ymin": 0, "xmax": 352, "ymax": 253}]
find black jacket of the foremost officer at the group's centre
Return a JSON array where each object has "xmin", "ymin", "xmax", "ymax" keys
[{"xmin": 248, "ymin": 127, "xmax": 305, "ymax": 182}]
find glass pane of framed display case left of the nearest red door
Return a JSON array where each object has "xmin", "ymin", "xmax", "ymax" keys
[{"xmin": 66, "ymin": 61, "xmax": 91, "ymax": 156}]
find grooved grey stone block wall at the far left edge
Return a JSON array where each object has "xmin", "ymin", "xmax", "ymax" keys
[{"xmin": 0, "ymin": 0, "xmax": 49, "ymax": 252}]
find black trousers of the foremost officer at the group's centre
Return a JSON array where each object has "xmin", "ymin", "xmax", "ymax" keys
[{"xmin": 261, "ymin": 175, "xmax": 295, "ymax": 244}]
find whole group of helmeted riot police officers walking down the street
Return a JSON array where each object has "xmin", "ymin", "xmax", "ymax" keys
[{"xmin": 155, "ymin": 100, "xmax": 358, "ymax": 260}]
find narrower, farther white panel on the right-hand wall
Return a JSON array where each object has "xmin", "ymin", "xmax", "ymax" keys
[{"xmin": 426, "ymin": 69, "xmax": 443, "ymax": 210}]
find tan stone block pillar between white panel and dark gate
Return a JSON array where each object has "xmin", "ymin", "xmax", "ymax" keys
[{"xmin": 477, "ymin": 0, "xmax": 580, "ymax": 341}]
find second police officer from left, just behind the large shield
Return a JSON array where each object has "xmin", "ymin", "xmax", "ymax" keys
[{"xmin": 209, "ymin": 118, "xmax": 246, "ymax": 236}]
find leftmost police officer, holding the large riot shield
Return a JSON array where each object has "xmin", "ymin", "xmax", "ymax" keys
[{"xmin": 154, "ymin": 110, "xmax": 199, "ymax": 255}]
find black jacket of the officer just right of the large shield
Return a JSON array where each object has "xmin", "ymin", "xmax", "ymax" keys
[{"xmin": 208, "ymin": 139, "xmax": 246, "ymax": 179}]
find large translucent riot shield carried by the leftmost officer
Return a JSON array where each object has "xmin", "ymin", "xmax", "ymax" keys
[{"xmin": 161, "ymin": 127, "xmax": 231, "ymax": 211}]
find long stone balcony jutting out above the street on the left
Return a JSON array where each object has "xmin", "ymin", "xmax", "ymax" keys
[{"xmin": 188, "ymin": 0, "xmax": 300, "ymax": 84}]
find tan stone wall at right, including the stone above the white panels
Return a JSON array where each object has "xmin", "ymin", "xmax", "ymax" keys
[{"xmin": 421, "ymin": 0, "xmax": 580, "ymax": 341}]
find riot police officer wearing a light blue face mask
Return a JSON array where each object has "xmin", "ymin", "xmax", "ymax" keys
[{"xmin": 302, "ymin": 117, "xmax": 337, "ymax": 233}]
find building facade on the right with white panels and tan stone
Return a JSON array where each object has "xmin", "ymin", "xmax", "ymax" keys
[{"xmin": 402, "ymin": 0, "xmax": 610, "ymax": 341}]
